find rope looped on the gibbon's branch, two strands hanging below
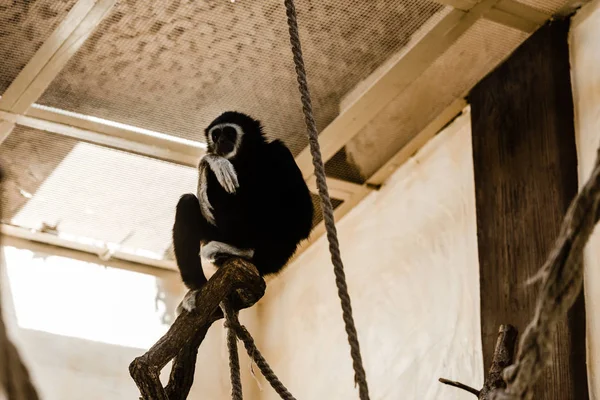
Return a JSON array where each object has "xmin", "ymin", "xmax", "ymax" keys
[{"xmin": 221, "ymin": 304, "xmax": 296, "ymax": 400}]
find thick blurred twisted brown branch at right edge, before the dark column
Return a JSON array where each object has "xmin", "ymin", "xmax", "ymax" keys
[{"xmin": 492, "ymin": 150, "xmax": 600, "ymax": 400}]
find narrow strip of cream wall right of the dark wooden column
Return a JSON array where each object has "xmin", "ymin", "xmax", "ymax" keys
[{"xmin": 570, "ymin": 1, "xmax": 600, "ymax": 400}]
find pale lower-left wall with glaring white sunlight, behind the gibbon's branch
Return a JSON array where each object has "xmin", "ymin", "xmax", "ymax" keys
[{"xmin": 0, "ymin": 247, "xmax": 257, "ymax": 400}]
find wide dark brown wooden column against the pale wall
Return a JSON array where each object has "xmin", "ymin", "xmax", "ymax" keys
[{"xmin": 469, "ymin": 17, "xmax": 588, "ymax": 400}]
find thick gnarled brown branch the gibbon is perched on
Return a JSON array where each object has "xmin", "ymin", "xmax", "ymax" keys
[{"xmin": 129, "ymin": 258, "xmax": 266, "ymax": 400}]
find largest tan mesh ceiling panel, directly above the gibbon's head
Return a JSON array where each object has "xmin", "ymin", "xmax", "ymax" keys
[{"xmin": 34, "ymin": 0, "xmax": 443, "ymax": 155}]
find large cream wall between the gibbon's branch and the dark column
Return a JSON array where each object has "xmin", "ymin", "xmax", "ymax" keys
[{"xmin": 259, "ymin": 110, "xmax": 483, "ymax": 400}]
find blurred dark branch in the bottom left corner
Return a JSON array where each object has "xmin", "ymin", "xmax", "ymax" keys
[{"xmin": 0, "ymin": 169, "xmax": 39, "ymax": 400}]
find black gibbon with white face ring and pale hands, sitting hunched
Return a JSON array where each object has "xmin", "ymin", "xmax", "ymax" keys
[{"xmin": 173, "ymin": 111, "xmax": 314, "ymax": 311}]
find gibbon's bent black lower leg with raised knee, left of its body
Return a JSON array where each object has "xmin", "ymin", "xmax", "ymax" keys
[{"xmin": 173, "ymin": 193, "xmax": 208, "ymax": 289}]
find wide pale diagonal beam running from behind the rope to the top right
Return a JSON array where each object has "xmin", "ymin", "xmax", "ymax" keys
[{"xmin": 296, "ymin": 0, "xmax": 497, "ymax": 178}]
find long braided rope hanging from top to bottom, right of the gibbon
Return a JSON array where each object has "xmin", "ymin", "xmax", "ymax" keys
[{"xmin": 285, "ymin": 0, "xmax": 369, "ymax": 400}]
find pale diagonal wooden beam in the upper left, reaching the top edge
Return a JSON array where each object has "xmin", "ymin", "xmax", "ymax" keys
[{"xmin": 0, "ymin": 0, "xmax": 116, "ymax": 114}]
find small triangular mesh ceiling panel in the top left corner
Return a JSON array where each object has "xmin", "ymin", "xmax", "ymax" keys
[{"xmin": 0, "ymin": 0, "xmax": 75, "ymax": 94}]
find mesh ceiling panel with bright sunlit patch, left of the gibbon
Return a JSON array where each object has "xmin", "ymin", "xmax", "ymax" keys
[{"xmin": 0, "ymin": 126, "xmax": 341, "ymax": 259}]
